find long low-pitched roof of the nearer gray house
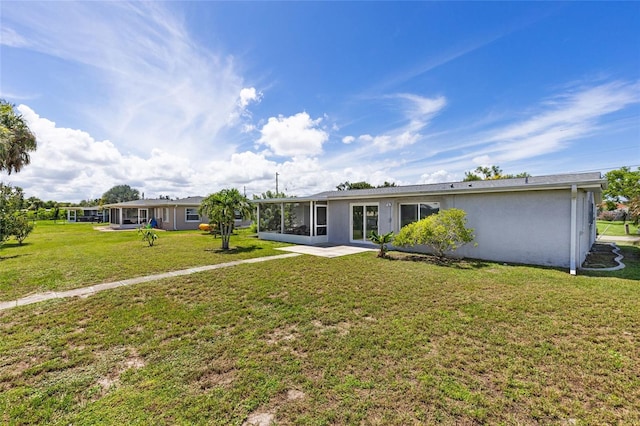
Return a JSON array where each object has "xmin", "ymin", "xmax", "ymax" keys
[{"xmin": 254, "ymin": 172, "xmax": 606, "ymax": 203}]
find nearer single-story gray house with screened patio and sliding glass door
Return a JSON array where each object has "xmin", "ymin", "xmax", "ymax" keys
[{"xmin": 254, "ymin": 173, "xmax": 606, "ymax": 274}]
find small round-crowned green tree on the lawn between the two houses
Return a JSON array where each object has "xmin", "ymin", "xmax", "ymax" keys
[{"xmin": 198, "ymin": 188, "xmax": 253, "ymax": 250}]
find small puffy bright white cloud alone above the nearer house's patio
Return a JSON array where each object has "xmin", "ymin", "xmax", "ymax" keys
[{"xmin": 257, "ymin": 112, "xmax": 329, "ymax": 157}]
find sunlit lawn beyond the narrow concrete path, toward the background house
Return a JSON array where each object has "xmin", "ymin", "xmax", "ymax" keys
[{"xmin": 0, "ymin": 221, "xmax": 285, "ymax": 301}]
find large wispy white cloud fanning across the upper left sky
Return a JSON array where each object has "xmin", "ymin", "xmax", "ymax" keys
[{"xmin": 3, "ymin": 2, "xmax": 245, "ymax": 162}]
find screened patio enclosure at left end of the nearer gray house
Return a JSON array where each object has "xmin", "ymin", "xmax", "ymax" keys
[{"xmin": 257, "ymin": 199, "xmax": 329, "ymax": 244}]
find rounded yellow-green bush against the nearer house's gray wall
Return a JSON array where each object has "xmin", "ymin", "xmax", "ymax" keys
[{"xmin": 393, "ymin": 208, "xmax": 475, "ymax": 258}]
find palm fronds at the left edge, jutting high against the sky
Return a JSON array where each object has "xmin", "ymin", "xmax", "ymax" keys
[{"xmin": 0, "ymin": 99, "xmax": 37, "ymax": 174}]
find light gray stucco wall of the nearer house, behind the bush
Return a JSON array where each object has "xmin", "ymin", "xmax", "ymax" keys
[{"xmin": 328, "ymin": 189, "xmax": 593, "ymax": 267}]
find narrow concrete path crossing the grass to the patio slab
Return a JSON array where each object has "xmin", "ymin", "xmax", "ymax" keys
[{"xmin": 0, "ymin": 253, "xmax": 301, "ymax": 311}]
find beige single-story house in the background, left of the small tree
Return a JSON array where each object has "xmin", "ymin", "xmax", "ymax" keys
[{"xmin": 103, "ymin": 197, "xmax": 209, "ymax": 231}]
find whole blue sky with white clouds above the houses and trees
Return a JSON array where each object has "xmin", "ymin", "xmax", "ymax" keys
[{"xmin": 0, "ymin": 1, "xmax": 640, "ymax": 201}]
